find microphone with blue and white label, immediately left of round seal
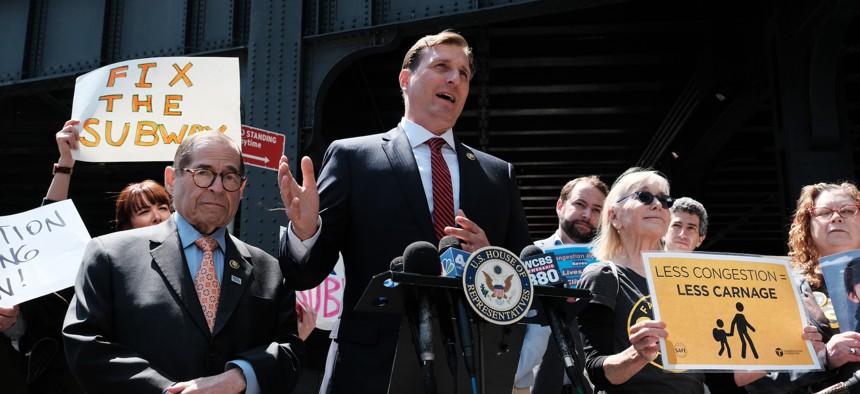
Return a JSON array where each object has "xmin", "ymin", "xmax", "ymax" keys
[{"xmin": 439, "ymin": 235, "xmax": 477, "ymax": 393}]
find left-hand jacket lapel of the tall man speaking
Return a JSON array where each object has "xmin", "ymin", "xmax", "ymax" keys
[{"xmin": 382, "ymin": 127, "xmax": 436, "ymax": 239}]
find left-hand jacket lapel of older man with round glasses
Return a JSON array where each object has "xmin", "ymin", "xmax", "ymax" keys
[{"xmin": 150, "ymin": 219, "xmax": 209, "ymax": 333}]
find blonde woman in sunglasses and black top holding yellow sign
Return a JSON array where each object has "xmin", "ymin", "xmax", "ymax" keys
[{"xmin": 578, "ymin": 168, "xmax": 796, "ymax": 393}]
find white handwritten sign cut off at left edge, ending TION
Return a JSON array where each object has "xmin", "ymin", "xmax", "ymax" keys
[{"xmin": 0, "ymin": 200, "xmax": 90, "ymax": 307}]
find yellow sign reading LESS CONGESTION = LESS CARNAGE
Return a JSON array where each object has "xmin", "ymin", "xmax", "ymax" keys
[{"xmin": 642, "ymin": 253, "xmax": 821, "ymax": 371}]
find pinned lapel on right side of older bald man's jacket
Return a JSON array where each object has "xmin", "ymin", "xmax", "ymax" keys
[{"xmin": 213, "ymin": 234, "xmax": 253, "ymax": 335}]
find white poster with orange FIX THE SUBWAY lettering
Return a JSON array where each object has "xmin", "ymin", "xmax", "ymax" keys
[{"xmin": 72, "ymin": 57, "xmax": 242, "ymax": 162}]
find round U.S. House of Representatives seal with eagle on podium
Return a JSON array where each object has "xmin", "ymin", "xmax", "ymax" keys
[{"xmin": 463, "ymin": 246, "xmax": 534, "ymax": 325}]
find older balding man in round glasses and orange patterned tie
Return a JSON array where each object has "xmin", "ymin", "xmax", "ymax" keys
[{"xmin": 63, "ymin": 132, "xmax": 304, "ymax": 393}]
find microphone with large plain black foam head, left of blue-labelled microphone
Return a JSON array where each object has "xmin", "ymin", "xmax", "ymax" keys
[{"xmin": 404, "ymin": 241, "xmax": 439, "ymax": 394}]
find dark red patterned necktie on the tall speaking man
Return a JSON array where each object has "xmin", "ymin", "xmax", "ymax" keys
[{"xmin": 427, "ymin": 138, "xmax": 454, "ymax": 239}]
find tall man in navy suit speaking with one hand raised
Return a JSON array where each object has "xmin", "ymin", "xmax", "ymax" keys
[{"xmin": 278, "ymin": 31, "xmax": 530, "ymax": 393}]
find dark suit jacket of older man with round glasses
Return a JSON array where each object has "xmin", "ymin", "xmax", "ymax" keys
[{"xmin": 63, "ymin": 218, "xmax": 304, "ymax": 393}]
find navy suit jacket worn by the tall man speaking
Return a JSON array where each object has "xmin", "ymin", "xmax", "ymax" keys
[{"xmin": 279, "ymin": 127, "xmax": 531, "ymax": 393}]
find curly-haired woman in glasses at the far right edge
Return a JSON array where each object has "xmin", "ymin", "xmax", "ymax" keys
[{"xmin": 747, "ymin": 182, "xmax": 860, "ymax": 393}]
